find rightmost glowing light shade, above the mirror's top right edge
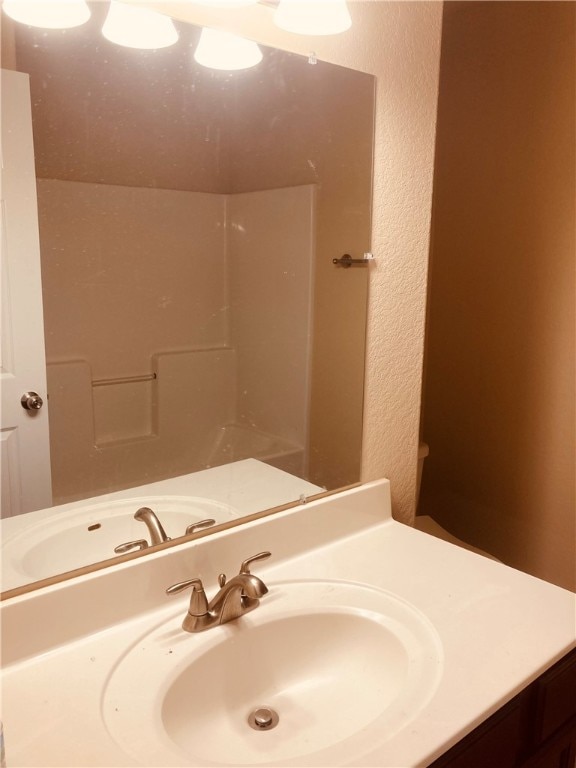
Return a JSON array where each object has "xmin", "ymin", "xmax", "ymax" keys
[{"xmin": 274, "ymin": 0, "xmax": 352, "ymax": 35}]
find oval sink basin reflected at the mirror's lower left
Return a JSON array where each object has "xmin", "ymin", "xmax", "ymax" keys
[{"xmin": 2, "ymin": 495, "xmax": 237, "ymax": 588}]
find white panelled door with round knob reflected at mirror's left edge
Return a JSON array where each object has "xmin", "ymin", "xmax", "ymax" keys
[{"xmin": 0, "ymin": 70, "xmax": 52, "ymax": 517}]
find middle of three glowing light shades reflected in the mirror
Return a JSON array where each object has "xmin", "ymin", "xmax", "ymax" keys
[{"xmin": 102, "ymin": 0, "xmax": 178, "ymax": 49}]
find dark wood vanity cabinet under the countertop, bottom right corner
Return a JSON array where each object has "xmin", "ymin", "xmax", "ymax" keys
[{"xmin": 429, "ymin": 649, "xmax": 576, "ymax": 768}]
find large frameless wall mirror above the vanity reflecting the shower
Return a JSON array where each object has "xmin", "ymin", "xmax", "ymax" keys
[{"xmin": 2, "ymin": 2, "xmax": 374, "ymax": 589}]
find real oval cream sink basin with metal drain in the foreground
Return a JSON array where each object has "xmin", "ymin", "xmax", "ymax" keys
[{"xmin": 102, "ymin": 581, "xmax": 442, "ymax": 766}]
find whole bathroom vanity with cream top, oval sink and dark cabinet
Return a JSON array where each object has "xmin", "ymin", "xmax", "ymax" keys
[{"xmin": 0, "ymin": 481, "xmax": 576, "ymax": 768}]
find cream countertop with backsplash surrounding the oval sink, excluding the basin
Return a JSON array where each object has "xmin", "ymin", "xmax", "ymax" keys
[{"xmin": 0, "ymin": 481, "xmax": 576, "ymax": 768}]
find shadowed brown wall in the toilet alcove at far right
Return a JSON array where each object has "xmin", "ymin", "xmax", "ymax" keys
[{"xmin": 420, "ymin": 2, "xmax": 576, "ymax": 589}]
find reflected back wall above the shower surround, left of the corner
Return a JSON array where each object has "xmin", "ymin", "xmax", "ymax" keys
[{"xmin": 10, "ymin": 0, "xmax": 230, "ymax": 193}]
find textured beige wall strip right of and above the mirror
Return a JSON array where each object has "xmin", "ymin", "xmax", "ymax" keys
[{"xmin": 154, "ymin": 0, "xmax": 442, "ymax": 522}]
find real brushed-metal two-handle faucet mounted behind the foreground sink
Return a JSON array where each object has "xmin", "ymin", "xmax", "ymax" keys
[{"xmin": 166, "ymin": 552, "xmax": 270, "ymax": 632}]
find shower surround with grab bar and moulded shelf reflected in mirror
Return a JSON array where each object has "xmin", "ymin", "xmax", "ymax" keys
[{"xmin": 38, "ymin": 179, "xmax": 315, "ymax": 503}]
